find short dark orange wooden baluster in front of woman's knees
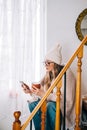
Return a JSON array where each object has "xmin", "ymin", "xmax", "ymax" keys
[{"xmin": 41, "ymin": 101, "xmax": 46, "ymax": 130}]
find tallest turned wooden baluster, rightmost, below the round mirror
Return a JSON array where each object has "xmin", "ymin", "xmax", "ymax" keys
[{"xmin": 75, "ymin": 48, "xmax": 83, "ymax": 130}]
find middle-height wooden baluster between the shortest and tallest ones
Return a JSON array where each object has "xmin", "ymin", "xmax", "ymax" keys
[{"xmin": 55, "ymin": 80, "xmax": 62, "ymax": 130}]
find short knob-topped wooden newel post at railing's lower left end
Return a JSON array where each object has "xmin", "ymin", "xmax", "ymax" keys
[{"xmin": 13, "ymin": 111, "xmax": 21, "ymax": 130}]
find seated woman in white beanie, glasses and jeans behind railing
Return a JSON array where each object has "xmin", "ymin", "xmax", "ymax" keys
[{"xmin": 22, "ymin": 45, "xmax": 75, "ymax": 130}]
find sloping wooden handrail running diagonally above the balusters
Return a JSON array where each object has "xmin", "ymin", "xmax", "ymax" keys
[{"xmin": 12, "ymin": 36, "xmax": 87, "ymax": 130}]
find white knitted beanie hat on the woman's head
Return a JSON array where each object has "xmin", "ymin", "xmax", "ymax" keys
[{"xmin": 45, "ymin": 44, "xmax": 62, "ymax": 65}]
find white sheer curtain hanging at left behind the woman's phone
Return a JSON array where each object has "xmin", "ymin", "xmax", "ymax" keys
[{"xmin": 0, "ymin": 0, "xmax": 46, "ymax": 130}]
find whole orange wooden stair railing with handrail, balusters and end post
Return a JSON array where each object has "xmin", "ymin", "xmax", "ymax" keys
[{"xmin": 12, "ymin": 36, "xmax": 87, "ymax": 130}]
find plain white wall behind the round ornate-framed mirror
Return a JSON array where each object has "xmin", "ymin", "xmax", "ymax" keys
[{"xmin": 47, "ymin": 0, "xmax": 87, "ymax": 94}]
